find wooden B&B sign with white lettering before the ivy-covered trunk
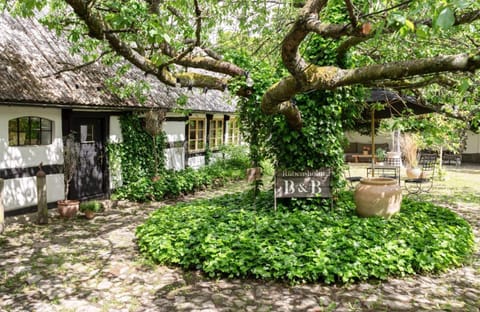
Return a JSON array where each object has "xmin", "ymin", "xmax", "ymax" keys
[{"xmin": 275, "ymin": 168, "xmax": 332, "ymax": 198}]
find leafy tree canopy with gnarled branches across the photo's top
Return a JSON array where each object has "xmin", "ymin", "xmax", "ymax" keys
[{"xmin": 3, "ymin": 0, "xmax": 480, "ymax": 117}]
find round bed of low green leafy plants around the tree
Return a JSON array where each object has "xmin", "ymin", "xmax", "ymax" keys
[{"xmin": 136, "ymin": 192, "xmax": 474, "ymax": 283}]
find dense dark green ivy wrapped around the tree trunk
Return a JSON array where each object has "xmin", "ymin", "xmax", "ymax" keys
[{"xmin": 229, "ymin": 36, "xmax": 363, "ymax": 195}]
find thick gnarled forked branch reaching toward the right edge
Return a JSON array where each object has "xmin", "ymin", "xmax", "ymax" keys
[{"xmin": 261, "ymin": 0, "xmax": 480, "ymax": 130}]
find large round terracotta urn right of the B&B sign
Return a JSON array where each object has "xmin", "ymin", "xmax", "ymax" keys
[{"xmin": 354, "ymin": 177, "xmax": 402, "ymax": 218}]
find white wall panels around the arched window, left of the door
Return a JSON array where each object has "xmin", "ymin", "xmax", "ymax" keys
[{"xmin": 0, "ymin": 106, "xmax": 64, "ymax": 211}]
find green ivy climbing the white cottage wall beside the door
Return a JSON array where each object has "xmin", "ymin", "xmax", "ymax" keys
[{"xmin": 108, "ymin": 113, "xmax": 166, "ymax": 184}]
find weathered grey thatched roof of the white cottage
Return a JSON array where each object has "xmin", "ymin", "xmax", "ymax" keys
[{"xmin": 0, "ymin": 13, "xmax": 235, "ymax": 112}]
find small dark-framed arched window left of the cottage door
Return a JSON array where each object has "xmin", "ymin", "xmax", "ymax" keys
[{"xmin": 8, "ymin": 116, "xmax": 53, "ymax": 146}]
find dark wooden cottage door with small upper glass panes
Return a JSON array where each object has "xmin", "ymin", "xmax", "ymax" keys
[{"xmin": 69, "ymin": 117, "xmax": 107, "ymax": 199}]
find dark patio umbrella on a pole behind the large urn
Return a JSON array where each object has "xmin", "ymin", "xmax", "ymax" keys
[{"xmin": 362, "ymin": 89, "xmax": 434, "ymax": 177}]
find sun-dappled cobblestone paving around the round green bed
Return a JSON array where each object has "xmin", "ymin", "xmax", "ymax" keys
[{"xmin": 0, "ymin": 172, "xmax": 480, "ymax": 312}]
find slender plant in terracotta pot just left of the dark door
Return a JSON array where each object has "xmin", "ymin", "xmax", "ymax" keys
[{"xmin": 57, "ymin": 132, "xmax": 80, "ymax": 218}]
